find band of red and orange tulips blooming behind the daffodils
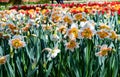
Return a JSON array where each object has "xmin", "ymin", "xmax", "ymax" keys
[{"xmin": 10, "ymin": 1, "xmax": 120, "ymax": 15}]
